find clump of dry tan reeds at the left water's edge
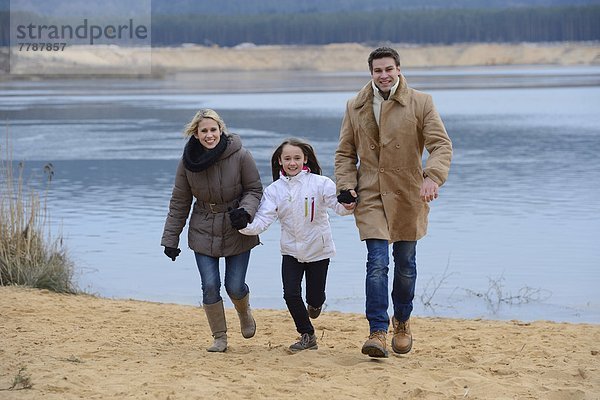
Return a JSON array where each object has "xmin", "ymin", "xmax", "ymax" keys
[{"xmin": 0, "ymin": 134, "xmax": 77, "ymax": 293}]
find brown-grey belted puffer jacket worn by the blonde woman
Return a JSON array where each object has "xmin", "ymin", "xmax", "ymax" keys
[{"xmin": 161, "ymin": 134, "xmax": 262, "ymax": 257}]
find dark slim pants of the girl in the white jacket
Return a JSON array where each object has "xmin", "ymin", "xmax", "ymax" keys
[{"xmin": 281, "ymin": 255, "xmax": 329, "ymax": 335}]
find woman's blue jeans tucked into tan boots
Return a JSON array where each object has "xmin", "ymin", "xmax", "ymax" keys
[{"xmin": 194, "ymin": 250, "xmax": 250, "ymax": 304}]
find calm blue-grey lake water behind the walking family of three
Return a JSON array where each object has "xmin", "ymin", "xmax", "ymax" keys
[{"xmin": 0, "ymin": 67, "xmax": 600, "ymax": 323}]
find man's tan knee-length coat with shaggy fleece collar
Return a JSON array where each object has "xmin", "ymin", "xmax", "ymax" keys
[{"xmin": 335, "ymin": 75, "xmax": 452, "ymax": 242}]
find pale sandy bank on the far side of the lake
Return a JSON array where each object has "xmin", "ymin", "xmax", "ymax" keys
[{"xmin": 0, "ymin": 42, "xmax": 600, "ymax": 78}]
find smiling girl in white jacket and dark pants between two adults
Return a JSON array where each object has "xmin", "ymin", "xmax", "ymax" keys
[{"xmin": 240, "ymin": 138, "xmax": 356, "ymax": 352}]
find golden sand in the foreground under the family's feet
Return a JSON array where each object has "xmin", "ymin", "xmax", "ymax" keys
[{"xmin": 0, "ymin": 287, "xmax": 600, "ymax": 400}]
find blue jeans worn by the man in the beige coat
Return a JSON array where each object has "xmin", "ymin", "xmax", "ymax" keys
[{"xmin": 365, "ymin": 239, "xmax": 417, "ymax": 332}]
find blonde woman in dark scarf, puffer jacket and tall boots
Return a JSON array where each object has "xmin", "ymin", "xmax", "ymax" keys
[{"xmin": 161, "ymin": 109, "xmax": 262, "ymax": 352}]
